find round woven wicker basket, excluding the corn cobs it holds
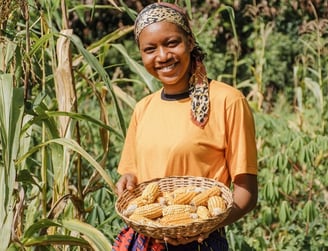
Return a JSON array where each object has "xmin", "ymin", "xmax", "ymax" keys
[{"xmin": 115, "ymin": 176, "xmax": 233, "ymax": 239}]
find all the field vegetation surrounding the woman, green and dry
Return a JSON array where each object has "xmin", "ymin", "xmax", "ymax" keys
[{"xmin": 0, "ymin": 0, "xmax": 328, "ymax": 250}]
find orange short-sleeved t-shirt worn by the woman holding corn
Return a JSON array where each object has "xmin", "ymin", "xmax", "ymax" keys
[{"xmin": 118, "ymin": 80, "xmax": 257, "ymax": 186}]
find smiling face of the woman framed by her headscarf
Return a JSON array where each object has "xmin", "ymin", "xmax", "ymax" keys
[{"xmin": 139, "ymin": 22, "xmax": 194, "ymax": 94}]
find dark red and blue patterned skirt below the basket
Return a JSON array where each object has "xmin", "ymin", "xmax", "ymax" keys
[{"xmin": 112, "ymin": 227, "xmax": 229, "ymax": 251}]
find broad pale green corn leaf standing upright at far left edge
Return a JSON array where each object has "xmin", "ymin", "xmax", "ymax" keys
[{"xmin": 0, "ymin": 74, "xmax": 24, "ymax": 250}]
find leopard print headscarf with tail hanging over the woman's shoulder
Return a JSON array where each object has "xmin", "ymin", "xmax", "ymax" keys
[{"xmin": 134, "ymin": 2, "xmax": 210, "ymax": 128}]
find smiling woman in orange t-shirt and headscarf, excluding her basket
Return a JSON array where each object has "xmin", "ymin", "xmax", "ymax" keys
[{"xmin": 113, "ymin": 3, "xmax": 257, "ymax": 250}]
